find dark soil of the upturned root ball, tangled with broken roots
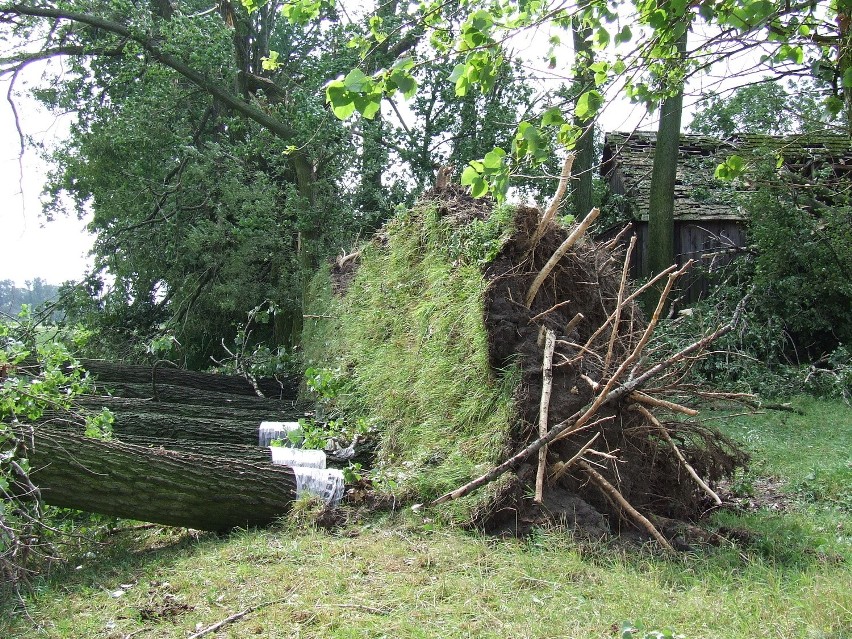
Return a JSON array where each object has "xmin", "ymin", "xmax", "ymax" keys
[{"xmin": 481, "ymin": 208, "xmax": 745, "ymax": 534}]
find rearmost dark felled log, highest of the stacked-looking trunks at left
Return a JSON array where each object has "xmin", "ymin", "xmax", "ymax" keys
[{"xmin": 80, "ymin": 359, "xmax": 299, "ymax": 400}]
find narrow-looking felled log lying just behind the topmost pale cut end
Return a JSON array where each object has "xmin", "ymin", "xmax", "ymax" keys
[{"xmin": 74, "ymin": 395, "xmax": 310, "ymax": 424}]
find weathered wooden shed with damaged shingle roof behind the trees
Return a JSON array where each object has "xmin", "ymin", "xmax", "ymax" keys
[{"xmin": 601, "ymin": 131, "xmax": 852, "ymax": 303}]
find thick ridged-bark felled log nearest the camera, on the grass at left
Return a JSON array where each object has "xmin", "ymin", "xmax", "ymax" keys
[{"xmin": 22, "ymin": 427, "xmax": 296, "ymax": 530}]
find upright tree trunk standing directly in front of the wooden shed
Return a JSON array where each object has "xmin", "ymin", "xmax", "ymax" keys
[{"xmin": 648, "ymin": 30, "xmax": 689, "ymax": 275}]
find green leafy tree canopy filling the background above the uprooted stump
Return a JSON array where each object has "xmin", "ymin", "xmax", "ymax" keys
[{"xmin": 0, "ymin": 0, "xmax": 852, "ymax": 362}]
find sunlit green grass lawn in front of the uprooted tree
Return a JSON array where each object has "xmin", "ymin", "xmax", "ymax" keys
[{"xmin": 0, "ymin": 399, "xmax": 852, "ymax": 639}]
